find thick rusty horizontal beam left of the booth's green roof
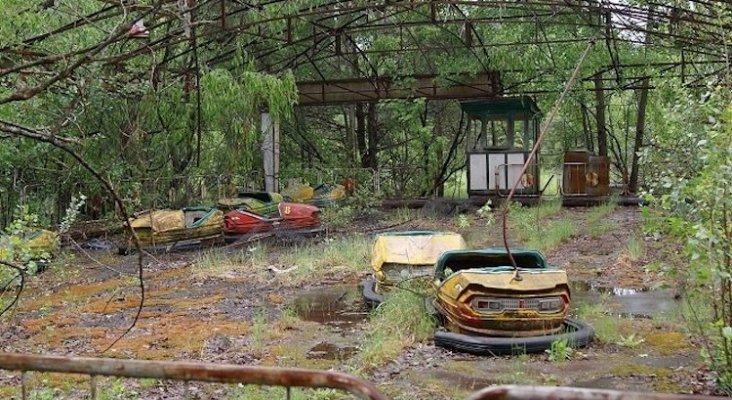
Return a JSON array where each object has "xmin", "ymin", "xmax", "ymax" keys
[{"xmin": 297, "ymin": 72, "xmax": 503, "ymax": 106}]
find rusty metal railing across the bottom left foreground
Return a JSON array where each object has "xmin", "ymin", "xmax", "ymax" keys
[{"xmin": 0, "ymin": 353, "xmax": 387, "ymax": 400}]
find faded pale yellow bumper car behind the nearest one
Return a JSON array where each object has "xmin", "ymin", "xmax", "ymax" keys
[{"xmin": 362, "ymin": 231, "xmax": 466, "ymax": 306}]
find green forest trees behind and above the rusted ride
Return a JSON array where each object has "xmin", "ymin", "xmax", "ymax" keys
[{"xmin": 0, "ymin": 0, "xmax": 728, "ymax": 225}]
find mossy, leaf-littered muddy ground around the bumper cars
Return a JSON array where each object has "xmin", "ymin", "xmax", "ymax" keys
[{"xmin": 0, "ymin": 208, "xmax": 711, "ymax": 399}]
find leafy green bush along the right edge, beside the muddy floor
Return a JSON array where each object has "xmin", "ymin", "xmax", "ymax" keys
[{"xmin": 645, "ymin": 83, "xmax": 732, "ymax": 395}]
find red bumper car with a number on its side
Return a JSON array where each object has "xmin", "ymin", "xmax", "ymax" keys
[{"xmin": 224, "ymin": 202, "xmax": 323, "ymax": 242}]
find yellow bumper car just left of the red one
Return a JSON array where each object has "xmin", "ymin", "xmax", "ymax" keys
[{"xmin": 119, "ymin": 206, "xmax": 224, "ymax": 254}]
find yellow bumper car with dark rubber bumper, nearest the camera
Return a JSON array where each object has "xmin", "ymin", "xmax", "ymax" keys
[{"xmin": 431, "ymin": 249, "xmax": 593, "ymax": 355}]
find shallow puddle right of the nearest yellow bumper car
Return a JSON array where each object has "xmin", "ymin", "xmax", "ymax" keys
[{"xmin": 572, "ymin": 282, "xmax": 679, "ymax": 318}]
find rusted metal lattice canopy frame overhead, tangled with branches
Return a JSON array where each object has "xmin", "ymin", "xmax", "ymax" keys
[{"xmin": 0, "ymin": 0, "xmax": 732, "ymax": 104}]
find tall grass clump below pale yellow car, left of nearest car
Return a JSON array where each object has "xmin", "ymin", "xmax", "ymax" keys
[{"xmin": 359, "ymin": 288, "xmax": 435, "ymax": 368}]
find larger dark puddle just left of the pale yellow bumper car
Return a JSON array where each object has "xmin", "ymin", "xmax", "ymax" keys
[{"xmin": 293, "ymin": 286, "xmax": 368, "ymax": 328}]
